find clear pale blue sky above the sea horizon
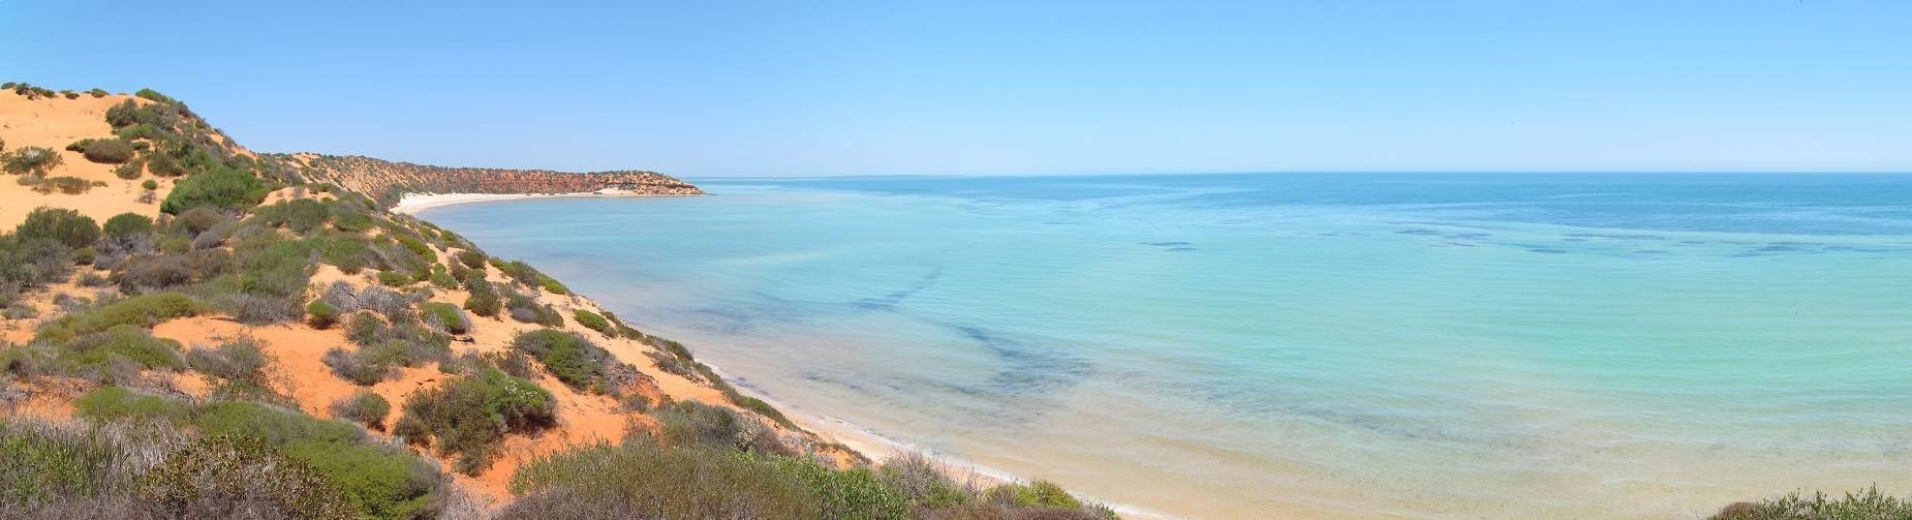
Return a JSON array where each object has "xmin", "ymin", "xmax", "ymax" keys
[{"xmin": 0, "ymin": 0, "xmax": 1912, "ymax": 178}]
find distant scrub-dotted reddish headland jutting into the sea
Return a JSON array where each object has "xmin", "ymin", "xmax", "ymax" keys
[{"xmin": 272, "ymin": 153, "xmax": 704, "ymax": 205}]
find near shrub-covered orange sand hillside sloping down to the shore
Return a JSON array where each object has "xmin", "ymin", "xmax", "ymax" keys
[{"xmin": 0, "ymin": 84, "xmax": 1115, "ymax": 520}]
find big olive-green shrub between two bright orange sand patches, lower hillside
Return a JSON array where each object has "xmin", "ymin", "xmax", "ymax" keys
[{"xmin": 392, "ymin": 367, "xmax": 556, "ymax": 474}]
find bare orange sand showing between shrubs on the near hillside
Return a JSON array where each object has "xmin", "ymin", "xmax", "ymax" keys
[{"xmin": 0, "ymin": 90, "xmax": 851, "ymax": 505}]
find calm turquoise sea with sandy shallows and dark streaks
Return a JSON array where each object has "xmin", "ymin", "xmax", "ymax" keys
[{"xmin": 423, "ymin": 174, "xmax": 1912, "ymax": 518}]
